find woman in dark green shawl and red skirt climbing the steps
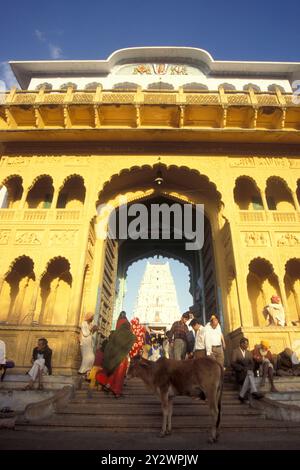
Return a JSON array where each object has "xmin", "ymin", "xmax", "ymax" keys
[{"xmin": 96, "ymin": 312, "xmax": 136, "ymax": 398}]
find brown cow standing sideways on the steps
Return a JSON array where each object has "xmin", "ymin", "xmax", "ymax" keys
[{"xmin": 128, "ymin": 357, "xmax": 223, "ymax": 443}]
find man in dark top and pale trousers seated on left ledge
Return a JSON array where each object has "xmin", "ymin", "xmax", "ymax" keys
[{"xmin": 24, "ymin": 338, "xmax": 52, "ymax": 390}]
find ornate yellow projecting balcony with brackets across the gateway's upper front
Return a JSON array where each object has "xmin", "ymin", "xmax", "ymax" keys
[{"xmin": 0, "ymin": 86, "xmax": 300, "ymax": 142}]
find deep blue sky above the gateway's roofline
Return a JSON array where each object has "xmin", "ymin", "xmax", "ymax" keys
[{"xmin": 0, "ymin": 0, "xmax": 300, "ymax": 85}]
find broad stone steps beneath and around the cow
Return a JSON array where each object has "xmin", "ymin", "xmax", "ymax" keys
[{"xmin": 11, "ymin": 379, "xmax": 300, "ymax": 434}]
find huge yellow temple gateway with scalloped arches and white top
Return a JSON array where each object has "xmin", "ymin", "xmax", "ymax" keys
[{"xmin": 0, "ymin": 47, "xmax": 300, "ymax": 375}]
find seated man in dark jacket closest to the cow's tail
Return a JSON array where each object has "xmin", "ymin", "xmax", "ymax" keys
[{"xmin": 231, "ymin": 338, "xmax": 263, "ymax": 403}]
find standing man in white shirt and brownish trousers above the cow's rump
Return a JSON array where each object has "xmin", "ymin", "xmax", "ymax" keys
[{"xmin": 204, "ymin": 315, "xmax": 226, "ymax": 367}]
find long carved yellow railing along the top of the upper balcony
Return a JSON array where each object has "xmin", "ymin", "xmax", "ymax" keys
[{"xmin": 3, "ymin": 86, "xmax": 293, "ymax": 107}]
